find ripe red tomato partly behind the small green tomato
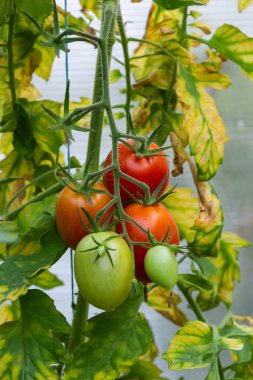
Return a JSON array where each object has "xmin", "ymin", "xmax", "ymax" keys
[{"xmin": 116, "ymin": 203, "xmax": 180, "ymax": 284}]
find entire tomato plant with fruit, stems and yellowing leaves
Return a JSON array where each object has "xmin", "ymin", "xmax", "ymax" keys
[{"xmin": 0, "ymin": 0, "xmax": 253, "ymax": 380}]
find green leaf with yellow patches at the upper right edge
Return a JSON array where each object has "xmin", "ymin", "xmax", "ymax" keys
[{"xmin": 209, "ymin": 24, "xmax": 253, "ymax": 79}]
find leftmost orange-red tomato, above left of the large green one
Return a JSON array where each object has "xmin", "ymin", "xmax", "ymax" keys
[{"xmin": 56, "ymin": 182, "xmax": 113, "ymax": 249}]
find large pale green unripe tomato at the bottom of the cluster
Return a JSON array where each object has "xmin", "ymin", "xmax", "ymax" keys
[{"xmin": 74, "ymin": 231, "xmax": 133, "ymax": 310}]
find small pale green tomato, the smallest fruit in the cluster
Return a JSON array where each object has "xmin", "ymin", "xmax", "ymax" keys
[{"xmin": 144, "ymin": 245, "xmax": 178, "ymax": 289}]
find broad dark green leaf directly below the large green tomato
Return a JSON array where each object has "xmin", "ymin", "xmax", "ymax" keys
[{"xmin": 64, "ymin": 286, "xmax": 152, "ymax": 380}]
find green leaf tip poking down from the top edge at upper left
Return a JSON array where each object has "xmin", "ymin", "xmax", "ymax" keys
[{"xmin": 16, "ymin": 0, "xmax": 53, "ymax": 24}]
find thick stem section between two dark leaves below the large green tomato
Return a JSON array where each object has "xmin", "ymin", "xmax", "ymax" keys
[{"xmin": 69, "ymin": 292, "xmax": 89, "ymax": 354}]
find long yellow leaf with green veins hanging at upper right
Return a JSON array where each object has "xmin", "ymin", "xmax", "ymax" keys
[{"xmin": 177, "ymin": 65, "xmax": 228, "ymax": 181}]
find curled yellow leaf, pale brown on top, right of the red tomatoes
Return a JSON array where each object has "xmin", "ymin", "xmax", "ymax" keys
[{"xmin": 190, "ymin": 182, "xmax": 223, "ymax": 256}]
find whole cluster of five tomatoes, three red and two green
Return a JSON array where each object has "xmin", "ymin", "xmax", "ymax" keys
[{"xmin": 56, "ymin": 140, "xmax": 180, "ymax": 310}]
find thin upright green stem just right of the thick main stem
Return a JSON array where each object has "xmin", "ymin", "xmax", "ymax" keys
[{"xmin": 117, "ymin": 4, "xmax": 132, "ymax": 133}]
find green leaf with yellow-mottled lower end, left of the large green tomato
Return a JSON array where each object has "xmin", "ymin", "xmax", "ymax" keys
[{"xmin": 0, "ymin": 228, "xmax": 66, "ymax": 302}]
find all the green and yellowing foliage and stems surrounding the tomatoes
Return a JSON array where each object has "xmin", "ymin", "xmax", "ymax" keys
[{"xmin": 0, "ymin": 0, "xmax": 253, "ymax": 380}]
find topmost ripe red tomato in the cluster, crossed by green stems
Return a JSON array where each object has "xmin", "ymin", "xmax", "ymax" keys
[{"xmin": 103, "ymin": 140, "xmax": 170, "ymax": 201}]
